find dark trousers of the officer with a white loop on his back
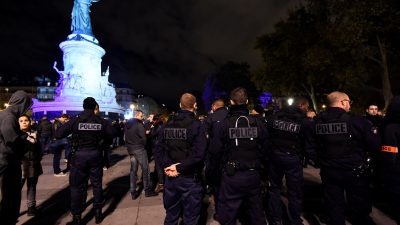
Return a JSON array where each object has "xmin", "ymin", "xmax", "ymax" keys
[{"xmin": 217, "ymin": 170, "xmax": 267, "ymax": 225}]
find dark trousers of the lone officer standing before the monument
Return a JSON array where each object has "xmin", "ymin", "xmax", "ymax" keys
[{"xmin": 69, "ymin": 149, "xmax": 103, "ymax": 215}]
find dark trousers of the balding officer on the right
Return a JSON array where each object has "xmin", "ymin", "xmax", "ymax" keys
[{"xmin": 321, "ymin": 168, "xmax": 372, "ymax": 225}]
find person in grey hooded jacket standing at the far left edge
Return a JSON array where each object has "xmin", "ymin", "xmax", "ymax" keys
[{"xmin": 0, "ymin": 91, "xmax": 32, "ymax": 225}]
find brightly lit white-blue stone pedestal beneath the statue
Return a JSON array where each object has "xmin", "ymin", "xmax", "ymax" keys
[{"xmin": 32, "ymin": 35, "xmax": 124, "ymax": 117}]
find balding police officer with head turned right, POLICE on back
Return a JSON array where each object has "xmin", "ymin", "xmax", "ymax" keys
[{"xmin": 315, "ymin": 91, "xmax": 380, "ymax": 225}]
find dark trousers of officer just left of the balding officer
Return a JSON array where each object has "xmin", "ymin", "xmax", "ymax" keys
[{"xmin": 268, "ymin": 152, "xmax": 304, "ymax": 225}]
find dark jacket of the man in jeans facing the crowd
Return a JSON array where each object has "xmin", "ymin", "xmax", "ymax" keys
[{"xmin": 124, "ymin": 118, "xmax": 146, "ymax": 154}]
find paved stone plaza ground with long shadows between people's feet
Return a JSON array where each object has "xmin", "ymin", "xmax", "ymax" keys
[{"xmin": 18, "ymin": 147, "xmax": 396, "ymax": 225}]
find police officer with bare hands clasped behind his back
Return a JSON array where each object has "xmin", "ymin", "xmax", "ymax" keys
[{"xmin": 154, "ymin": 93, "xmax": 207, "ymax": 225}]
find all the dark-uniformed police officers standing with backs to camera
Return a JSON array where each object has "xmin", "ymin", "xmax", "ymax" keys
[{"xmin": 0, "ymin": 87, "xmax": 400, "ymax": 225}]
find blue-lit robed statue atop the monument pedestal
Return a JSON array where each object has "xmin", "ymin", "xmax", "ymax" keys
[{"xmin": 71, "ymin": 0, "xmax": 100, "ymax": 37}]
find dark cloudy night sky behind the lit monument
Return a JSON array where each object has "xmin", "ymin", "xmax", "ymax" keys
[{"xmin": 0, "ymin": 0, "xmax": 299, "ymax": 103}]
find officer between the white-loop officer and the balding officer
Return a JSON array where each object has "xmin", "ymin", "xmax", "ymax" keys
[{"xmin": 268, "ymin": 97, "xmax": 315, "ymax": 225}]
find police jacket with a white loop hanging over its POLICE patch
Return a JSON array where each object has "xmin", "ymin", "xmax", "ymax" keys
[{"xmin": 210, "ymin": 105, "xmax": 268, "ymax": 170}]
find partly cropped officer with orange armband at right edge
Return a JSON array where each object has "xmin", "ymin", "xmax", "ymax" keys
[{"xmin": 379, "ymin": 96, "xmax": 400, "ymax": 224}]
